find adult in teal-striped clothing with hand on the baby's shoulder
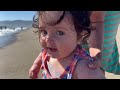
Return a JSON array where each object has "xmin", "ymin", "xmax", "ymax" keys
[{"xmin": 89, "ymin": 11, "xmax": 120, "ymax": 75}]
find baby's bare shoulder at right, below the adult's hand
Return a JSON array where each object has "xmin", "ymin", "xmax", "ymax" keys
[{"xmin": 74, "ymin": 60, "xmax": 105, "ymax": 79}]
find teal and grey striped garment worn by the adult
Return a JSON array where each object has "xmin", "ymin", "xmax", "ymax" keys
[{"xmin": 102, "ymin": 11, "xmax": 120, "ymax": 75}]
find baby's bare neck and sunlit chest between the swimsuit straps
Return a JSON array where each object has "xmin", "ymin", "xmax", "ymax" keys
[{"xmin": 47, "ymin": 49, "xmax": 76, "ymax": 78}]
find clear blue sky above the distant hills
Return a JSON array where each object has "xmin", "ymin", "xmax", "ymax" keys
[{"xmin": 0, "ymin": 11, "xmax": 36, "ymax": 21}]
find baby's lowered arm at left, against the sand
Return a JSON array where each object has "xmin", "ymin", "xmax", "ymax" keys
[{"xmin": 29, "ymin": 53, "xmax": 42, "ymax": 79}]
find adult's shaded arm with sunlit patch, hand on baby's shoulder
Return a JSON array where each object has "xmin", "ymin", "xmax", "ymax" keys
[{"xmin": 89, "ymin": 11, "xmax": 105, "ymax": 68}]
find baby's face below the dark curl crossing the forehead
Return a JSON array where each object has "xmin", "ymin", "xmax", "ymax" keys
[{"xmin": 39, "ymin": 11, "xmax": 77, "ymax": 59}]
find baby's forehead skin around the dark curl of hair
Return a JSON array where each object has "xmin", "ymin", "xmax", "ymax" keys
[{"xmin": 39, "ymin": 11, "xmax": 74, "ymax": 28}]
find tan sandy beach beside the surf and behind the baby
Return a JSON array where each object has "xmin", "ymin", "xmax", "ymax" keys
[{"xmin": 0, "ymin": 29, "xmax": 120, "ymax": 79}]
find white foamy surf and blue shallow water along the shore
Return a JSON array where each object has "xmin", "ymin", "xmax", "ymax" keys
[{"xmin": 0, "ymin": 28, "xmax": 27, "ymax": 48}]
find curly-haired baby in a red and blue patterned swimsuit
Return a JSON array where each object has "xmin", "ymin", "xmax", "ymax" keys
[{"xmin": 29, "ymin": 11, "xmax": 105, "ymax": 79}]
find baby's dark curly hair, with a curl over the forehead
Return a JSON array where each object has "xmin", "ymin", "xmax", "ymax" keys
[{"xmin": 33, "ymin": 11, "xmax": 95, "ymax": 44}]
